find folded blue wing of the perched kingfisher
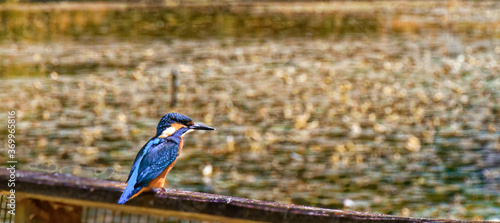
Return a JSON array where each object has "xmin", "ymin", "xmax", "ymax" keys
[{"xmin": 136, "ymin": 140, "xmax": 179, "ymax": 187}]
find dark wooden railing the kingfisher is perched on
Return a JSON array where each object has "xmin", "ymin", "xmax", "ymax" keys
[{"xmin": 0, "ymin": 169, "xmax": 472, "ymax": 223}]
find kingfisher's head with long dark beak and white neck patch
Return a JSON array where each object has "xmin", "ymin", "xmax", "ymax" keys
[{"xmin": 156, "ymin": 113, "xmax": 215, "ymax": 138}]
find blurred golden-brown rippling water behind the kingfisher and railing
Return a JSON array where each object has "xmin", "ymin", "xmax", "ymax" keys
[{"xmin": 0, "ymin": 0, "xmax": 500, "ymax": 220}]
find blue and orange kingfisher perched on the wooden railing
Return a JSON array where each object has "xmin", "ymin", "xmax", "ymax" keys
[{"xmin": 118, "ymin": 113, "xmax": 215, "ymax": 204}]
